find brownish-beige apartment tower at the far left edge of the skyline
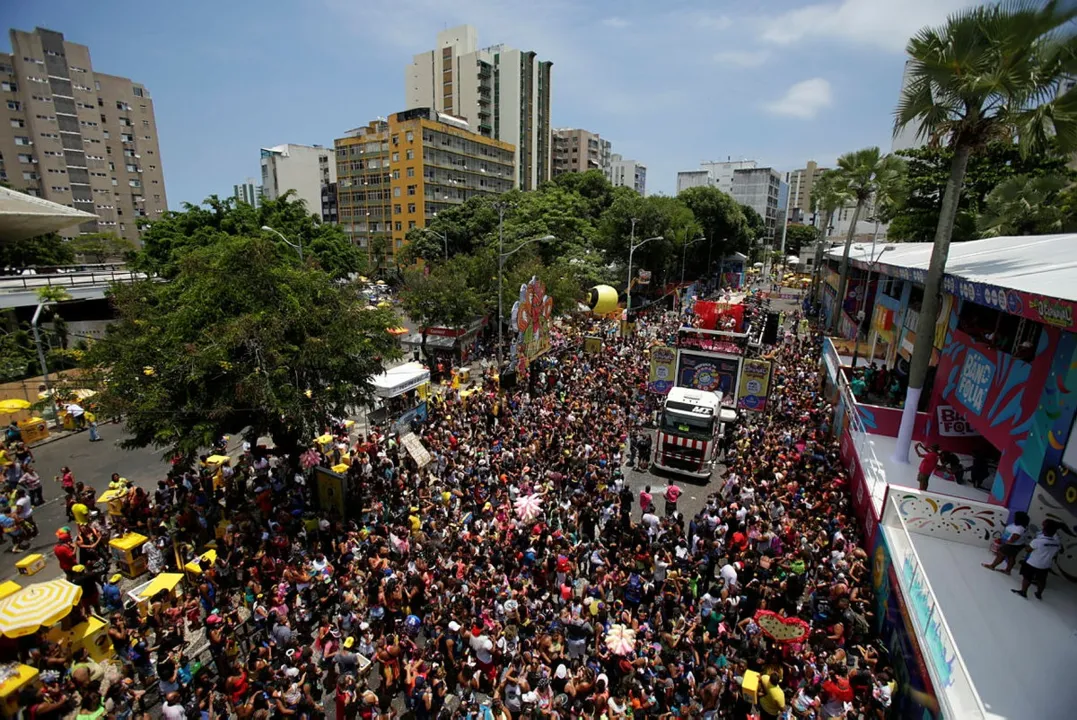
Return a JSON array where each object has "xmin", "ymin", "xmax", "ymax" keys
[{"xmin": 0, "ymin": 28, "xmax": 168, "ymax": 243}]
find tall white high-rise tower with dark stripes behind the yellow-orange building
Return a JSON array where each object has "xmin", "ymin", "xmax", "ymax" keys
[{"xmin": 404, "ymin": 25, "xmax": 554, "ymax": 190}]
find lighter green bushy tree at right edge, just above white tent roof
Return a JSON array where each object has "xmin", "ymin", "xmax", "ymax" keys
[{"xmin": 976, "ymin": 175, "xmax": 1073, "ymax": 238}]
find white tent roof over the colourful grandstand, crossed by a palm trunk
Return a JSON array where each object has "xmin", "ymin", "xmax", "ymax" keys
[{"xmin": 829, "ymin": 234, "xmax": 1077, "ymax": 301}]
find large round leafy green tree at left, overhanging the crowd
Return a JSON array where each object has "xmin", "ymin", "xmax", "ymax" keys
[{"xmin": 86, "ymin": 234, "xmax": 398, "ymax": 458}]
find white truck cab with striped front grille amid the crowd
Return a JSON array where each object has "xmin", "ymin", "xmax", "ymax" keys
[{"xmin": 655, "ymin": 387, "xmax": 732, "ymax": 478}]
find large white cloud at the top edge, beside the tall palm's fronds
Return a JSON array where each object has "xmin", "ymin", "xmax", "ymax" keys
[{"xmin": 763, "ymin": 0, "xmax": 978, "ymax": 53}]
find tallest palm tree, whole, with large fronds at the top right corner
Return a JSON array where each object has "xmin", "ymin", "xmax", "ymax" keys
[{"xmin": 894, "ymin": 0, "xmax": 1077, "ymax": 463}]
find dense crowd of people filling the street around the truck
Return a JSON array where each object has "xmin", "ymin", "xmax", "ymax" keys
[{"xmin": 6, "ymin": 292, "xmax": 908, "ymax": 720}]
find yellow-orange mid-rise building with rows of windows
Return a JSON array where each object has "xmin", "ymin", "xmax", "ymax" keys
[{"xmin": 334, "ymin": 108, "xmax": 516, "ymax": 266}]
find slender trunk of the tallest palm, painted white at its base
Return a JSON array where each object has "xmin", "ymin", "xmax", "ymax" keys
[{"xmin": 894, "ymin": 145, "xmax": 973, "ymax": 463}]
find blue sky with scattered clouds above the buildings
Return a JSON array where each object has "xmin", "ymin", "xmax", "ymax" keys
[{"xmin": 2, "ymin": 0, "xmax": 974, "ymax": 209}]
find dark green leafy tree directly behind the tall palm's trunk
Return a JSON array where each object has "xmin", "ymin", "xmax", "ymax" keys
[{"xmin": 886, "ymin": 140, "xmax": 1074, "ymax": 242}]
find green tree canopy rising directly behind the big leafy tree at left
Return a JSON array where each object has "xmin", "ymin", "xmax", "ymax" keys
[{"xmin": 134, "ymin": 190, "xmax": 366, "ymax": 279}]
